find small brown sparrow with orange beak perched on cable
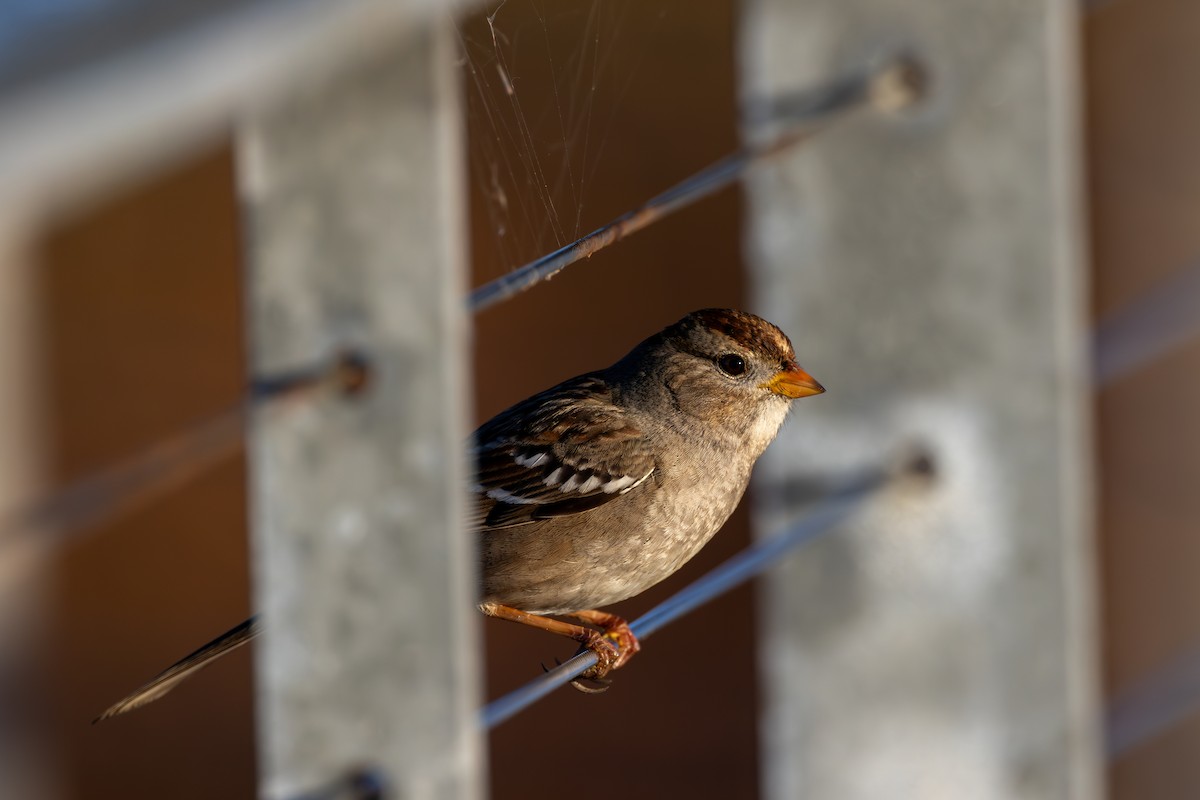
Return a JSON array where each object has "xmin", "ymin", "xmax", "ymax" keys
[{"xmin": 96, "ymin": 308, "xmax": 824, "ymax": 721}]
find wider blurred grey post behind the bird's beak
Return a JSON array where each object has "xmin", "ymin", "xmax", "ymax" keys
[{"xmin": 742, "ymin": 0, "xmax": 1102, "ymax": 800}]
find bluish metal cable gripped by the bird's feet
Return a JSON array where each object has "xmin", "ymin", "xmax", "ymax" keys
[{"xmin": 480, "ymin": 471, "xmax": 887, "ymax": 729}]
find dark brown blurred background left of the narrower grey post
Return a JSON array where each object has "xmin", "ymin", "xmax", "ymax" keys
[{"xmin": 34, "ymin": 149, "xmax": 254, "ymax": 800}]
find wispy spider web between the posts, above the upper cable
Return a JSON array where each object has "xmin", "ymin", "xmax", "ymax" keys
[{"xmin": 457, "ymin": 0, "xmax": 666, "ymax": 277}]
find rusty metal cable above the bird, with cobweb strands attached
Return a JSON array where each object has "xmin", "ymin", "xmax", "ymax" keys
[{"xmin": 468, "ymin": 58, "xmax": 923, "ymax": 312}]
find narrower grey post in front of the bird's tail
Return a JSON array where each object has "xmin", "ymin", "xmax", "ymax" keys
[{"xmin": 241, "ymin": 20, "xmax": 481, "ymax": 799}]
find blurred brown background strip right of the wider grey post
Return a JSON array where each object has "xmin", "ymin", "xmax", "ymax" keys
[{"xmin": 1084, "ymin": 0, "xmax": 1200, "ymax": 800}]
